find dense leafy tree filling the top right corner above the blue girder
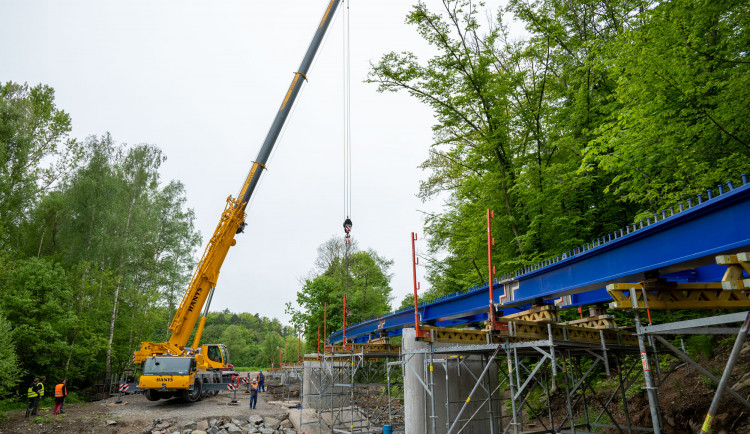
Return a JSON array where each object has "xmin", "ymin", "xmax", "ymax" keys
[{"xmin": 582, "ymin": 0, "xmax": 750, "ymax": 210}]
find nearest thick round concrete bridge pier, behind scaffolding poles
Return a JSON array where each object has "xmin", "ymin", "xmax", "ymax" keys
[{"xmin": 401, "ymin": 328, "xmax": 504, "ymax": 434}]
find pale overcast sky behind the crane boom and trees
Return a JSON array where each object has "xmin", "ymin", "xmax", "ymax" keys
[{"xmin": 0, "ymin": 0, "xmax": 512, "ymax": 322}]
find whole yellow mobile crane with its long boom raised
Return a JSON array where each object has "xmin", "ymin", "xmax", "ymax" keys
[{"xmin": 133, "ymin": 0, "xmax": 340, "ymax": 401}]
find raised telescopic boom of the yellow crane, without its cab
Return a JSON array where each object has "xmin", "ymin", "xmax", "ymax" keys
[{"xmin": 134, "ymin": 0, "xmax": 340, "ymax": 363}]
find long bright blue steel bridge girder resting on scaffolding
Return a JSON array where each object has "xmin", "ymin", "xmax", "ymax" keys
[{"xmin": 330, "ymin": 178, "xmax": 750, "ymax": 343}]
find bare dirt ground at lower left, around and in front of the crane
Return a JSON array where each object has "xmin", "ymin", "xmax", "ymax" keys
[{"xmin": 0, "ymin": 372, "xmax": 288, "ymax": 434}]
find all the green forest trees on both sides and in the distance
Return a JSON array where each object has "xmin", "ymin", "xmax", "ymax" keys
[{"xmin": 0, "ymin": 0, "xmax": 750, "ymax": 406}]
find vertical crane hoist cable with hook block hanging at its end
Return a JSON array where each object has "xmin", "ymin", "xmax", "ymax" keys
[{"xmin": 342, "ymin": 0, "xmax": 352, "ymax": 245}]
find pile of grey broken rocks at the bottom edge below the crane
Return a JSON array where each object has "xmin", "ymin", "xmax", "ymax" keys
[{"xmin": 142, "ymin": 415, "xmax": 297, "ymax": 434}]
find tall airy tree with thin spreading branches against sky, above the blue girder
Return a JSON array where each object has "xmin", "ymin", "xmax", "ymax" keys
[{"xmin": 369, "ymin": 0, "xmax": 636, "ymax": 296}]
